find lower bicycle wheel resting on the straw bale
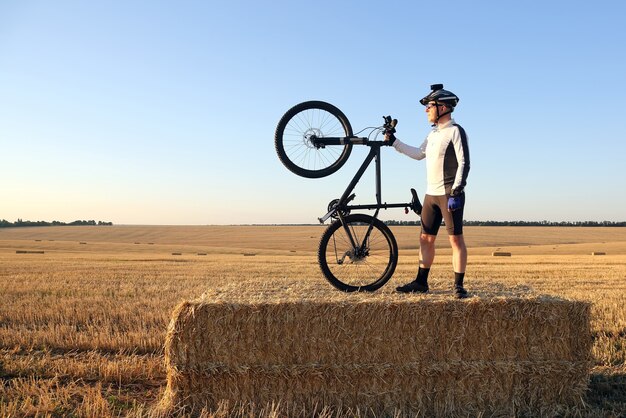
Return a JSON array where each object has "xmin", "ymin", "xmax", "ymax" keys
[{"xmin": 318, "ymin": 213, "xmax": 398, "ymax": 292}]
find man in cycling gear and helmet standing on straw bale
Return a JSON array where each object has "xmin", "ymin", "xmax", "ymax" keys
[{"xmin": 385, "ymin": 84, "xmax": 470, "ymax": 298}]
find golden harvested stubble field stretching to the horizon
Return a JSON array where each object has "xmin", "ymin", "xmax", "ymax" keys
[{"xmin": 0, "ymin": 226, "xmax": 626, "ymax": 417}]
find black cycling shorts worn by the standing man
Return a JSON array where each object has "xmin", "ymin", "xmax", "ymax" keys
[{"xmin": 422, "ymin": 193, "xmax": 465, "ymax": 235}]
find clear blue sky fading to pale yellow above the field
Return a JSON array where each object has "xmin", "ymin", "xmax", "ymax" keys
[{"xmin": 0, "ymin": 0, "xmax": 626, "ymax": 224}]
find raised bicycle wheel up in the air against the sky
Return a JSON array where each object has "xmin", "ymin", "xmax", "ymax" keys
[{"xmin": 274, "ymin": 101, "xmax": 352, "ymax": 178}]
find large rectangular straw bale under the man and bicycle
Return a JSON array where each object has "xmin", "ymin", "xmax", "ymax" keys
[{"xmin": 160, "ymin": 286, "xmax": 592, "ymax": 416}]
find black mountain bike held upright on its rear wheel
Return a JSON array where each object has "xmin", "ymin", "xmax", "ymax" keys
[{"xmin": 274, "ymin": 101, "xmax": 422, "ymax": 292}]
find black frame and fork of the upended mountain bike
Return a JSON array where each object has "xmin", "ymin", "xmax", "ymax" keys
[{"xmin": 310, "ymin": 136, "xmax": 411, "ymax": 224}]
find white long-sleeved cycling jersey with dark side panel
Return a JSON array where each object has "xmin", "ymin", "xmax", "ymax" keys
[{"xmin": 393, "ymin": 119, "xmax": 470, "ymax": 196}]
